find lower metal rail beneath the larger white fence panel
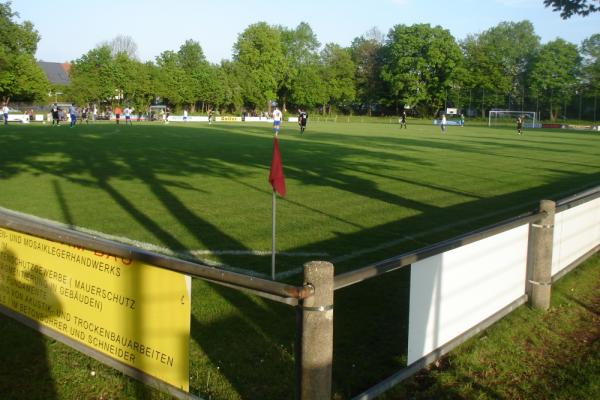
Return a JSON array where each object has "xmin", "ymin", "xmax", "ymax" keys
[{"xmin": 352, "ymin": 294, "xmax": 527, "ymax": 400}]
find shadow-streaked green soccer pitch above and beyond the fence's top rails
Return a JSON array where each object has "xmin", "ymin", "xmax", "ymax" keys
[{"xmin": 0, "ymin": 123, "xmax": 600, "ymax": 279}]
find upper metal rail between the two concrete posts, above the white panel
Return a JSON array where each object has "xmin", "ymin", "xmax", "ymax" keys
[{"xmin": 334, "ymin": 212, "xmax": 542, "ymax": 290}]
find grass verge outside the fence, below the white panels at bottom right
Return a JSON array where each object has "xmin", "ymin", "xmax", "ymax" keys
[{"xmin": 382, "ymin": 254, "xmax": 600, "ymax": 400}]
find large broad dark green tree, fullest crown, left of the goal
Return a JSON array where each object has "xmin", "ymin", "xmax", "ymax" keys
[{"xmin": 381, "ymin": 24, "xmax": 462, "ymax": 114}]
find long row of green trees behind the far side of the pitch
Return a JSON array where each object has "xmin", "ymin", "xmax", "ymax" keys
[{"xmin": 0, "ymin": 3, "xmax": 600, "ymax": 119}]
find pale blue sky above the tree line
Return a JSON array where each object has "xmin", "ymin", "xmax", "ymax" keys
[{"xmin": 8, "ymin": 0, "xmax": 600, "ymax": 63}]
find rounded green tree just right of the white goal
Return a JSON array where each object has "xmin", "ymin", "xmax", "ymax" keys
[{"xmin": 528, "ymin": 39, "xmax": 581, "ymax": 121}]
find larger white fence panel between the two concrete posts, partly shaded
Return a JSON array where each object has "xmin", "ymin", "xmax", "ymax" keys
[{"xmin": 408, "ymin": 224, "xmax": 529, "ymax": 365}]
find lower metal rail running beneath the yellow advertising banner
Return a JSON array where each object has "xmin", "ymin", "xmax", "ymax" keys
[{"xmin": 0, "ymin": 305, "xmax": 202, "ymax": 400}]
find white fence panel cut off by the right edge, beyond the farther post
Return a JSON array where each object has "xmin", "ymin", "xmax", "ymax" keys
[{"xmin": 552, "ymin": 198, "xmax": 600, "ymax": 276}]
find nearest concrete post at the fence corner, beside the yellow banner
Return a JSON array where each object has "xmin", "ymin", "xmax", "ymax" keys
[{"xmin": 300, "ymin": 261, "xmax": 334, "ymax": 400}]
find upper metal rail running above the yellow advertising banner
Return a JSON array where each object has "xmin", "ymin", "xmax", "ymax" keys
[{"xmin": 0, "ymin": 208, "xmax": 311, "ymax": 299}]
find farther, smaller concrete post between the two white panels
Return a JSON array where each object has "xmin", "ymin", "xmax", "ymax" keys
[{"xmin": 529, "ymin": 200, "xmax": 556, "ymax": 310}]
